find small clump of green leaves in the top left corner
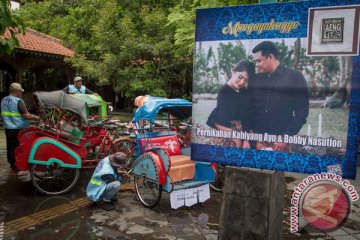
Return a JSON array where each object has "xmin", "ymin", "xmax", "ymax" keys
[{"xmin": 0, "ymin": 0, "xmax": 25, "ymax": 55}]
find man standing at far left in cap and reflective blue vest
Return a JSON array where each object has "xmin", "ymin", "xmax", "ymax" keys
[{"xmin": 1, "ymin": 82, "xmax": 39, "ymax": 175}]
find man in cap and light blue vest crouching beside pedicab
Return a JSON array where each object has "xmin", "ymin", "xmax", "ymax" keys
[{"xmin": 86, "ymin": 152, "xmax": 133, "ymax": 211}]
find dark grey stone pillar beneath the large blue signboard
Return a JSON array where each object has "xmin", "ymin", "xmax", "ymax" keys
[{"xmin": 219, "ymin": 166, "xmax": 285, "ymax": 240}]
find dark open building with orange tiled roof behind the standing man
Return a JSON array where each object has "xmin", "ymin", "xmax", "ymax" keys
[{"xmin": 0, "ymin": 28, "xmax": 75, "ymax": 109}]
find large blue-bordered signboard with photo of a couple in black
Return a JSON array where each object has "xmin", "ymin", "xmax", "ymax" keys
[{"xmin": 192, "ymin": 0, "xmax": 360, "ymax": 178}]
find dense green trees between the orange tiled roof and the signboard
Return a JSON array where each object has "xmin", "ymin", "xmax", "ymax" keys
[{"xmin": 20, "ymin": 0, "xmax": 257, "ymax": 105}]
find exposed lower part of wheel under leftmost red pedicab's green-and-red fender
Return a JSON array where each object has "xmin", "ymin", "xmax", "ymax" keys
[{"xmin": 30, "ymin": 163, "xmax": 80, "ymax": 195}]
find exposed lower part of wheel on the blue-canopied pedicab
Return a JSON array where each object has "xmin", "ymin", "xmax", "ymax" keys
[{"xmin": 135, "ymin": 176, "xmax": 162, "ymax": 208}]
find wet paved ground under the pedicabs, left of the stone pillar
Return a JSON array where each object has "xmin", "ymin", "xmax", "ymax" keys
[{"xmin": 0, "ymin": 152, "xmax": 222, "ymax": 240}]
